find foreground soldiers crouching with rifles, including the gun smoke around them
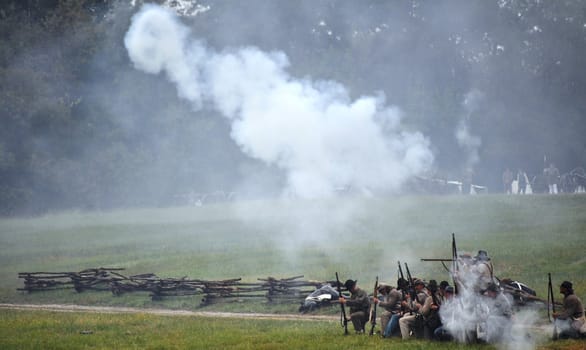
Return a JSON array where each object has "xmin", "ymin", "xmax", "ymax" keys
[{"xmin": 336, "ymin": 251, "xmax": 586, "ymax": 343}]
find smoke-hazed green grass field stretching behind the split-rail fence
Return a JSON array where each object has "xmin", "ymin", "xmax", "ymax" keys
[{"xmin": 0, "ymin": 195, "xmax": 586, "ymax": 348}]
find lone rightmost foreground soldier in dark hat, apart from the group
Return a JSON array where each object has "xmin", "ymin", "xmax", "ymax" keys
[{"xmin": 553, "ymin": 281, "xmax": 585, "ymax": 339}]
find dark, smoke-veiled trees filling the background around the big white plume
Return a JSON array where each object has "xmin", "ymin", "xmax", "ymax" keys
[{"xmin": 0, "ymin": 0, "xmax": 586, "ymax": 215}]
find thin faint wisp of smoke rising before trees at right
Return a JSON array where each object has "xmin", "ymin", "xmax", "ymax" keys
[{"xmin": 456, "ymin": 90, "xmax": 484, "ymax": 169}]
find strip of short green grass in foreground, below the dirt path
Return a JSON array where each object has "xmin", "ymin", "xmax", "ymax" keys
[{"xmin": 0, "ymin": 311, "xmax": 584, "ymax": 350}]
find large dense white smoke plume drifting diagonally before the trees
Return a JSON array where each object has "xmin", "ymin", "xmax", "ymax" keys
[{"xmin": 125, "ymin": 5, "xmax": 433, "ymax": 198}]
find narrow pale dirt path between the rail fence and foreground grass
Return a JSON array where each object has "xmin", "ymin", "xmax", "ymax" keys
[{"xmin": 0, "ymin": 304, "xmax": 338, "ymax": 321}]
